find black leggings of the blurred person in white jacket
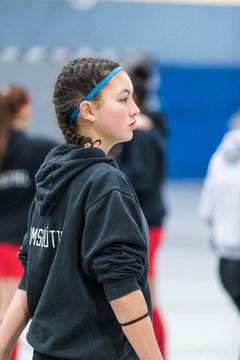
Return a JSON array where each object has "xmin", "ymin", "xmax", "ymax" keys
[{"xmin": 219, "ymin": 258, "xmax": 240, "ymax": 311}]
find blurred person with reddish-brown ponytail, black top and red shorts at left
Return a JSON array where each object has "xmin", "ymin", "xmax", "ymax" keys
[{"xmin": 0, "ymin": 85, "xmax": 55, "ymax": 360}]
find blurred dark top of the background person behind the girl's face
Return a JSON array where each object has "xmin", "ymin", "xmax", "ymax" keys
[{"xmin": 116, "ymin": 118, "xmax": 167, "ymax": 227}]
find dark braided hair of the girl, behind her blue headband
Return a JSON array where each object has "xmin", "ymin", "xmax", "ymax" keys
[{"xmin": 53, "ymin": 58, "xmax": 119, "ymax": 147}]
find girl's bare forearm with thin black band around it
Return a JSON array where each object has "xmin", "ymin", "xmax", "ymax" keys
[{"xmin": 110, "ymin": 290, "xmax": 163, "ymax": 360}]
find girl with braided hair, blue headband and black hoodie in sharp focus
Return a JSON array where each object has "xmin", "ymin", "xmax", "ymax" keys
[{"xmin": 0, "ymin": 58, "xmax": 162, "ymax": 360}]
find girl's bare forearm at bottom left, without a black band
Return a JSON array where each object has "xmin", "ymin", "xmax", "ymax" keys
[{"xmin": 0, "ymin": 289, "xmax": 30, "ymax": 360}]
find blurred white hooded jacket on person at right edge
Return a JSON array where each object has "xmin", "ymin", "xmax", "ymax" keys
[{"xmin": 200, "ymin": 129, "xmax": 240, "ymax": 260}]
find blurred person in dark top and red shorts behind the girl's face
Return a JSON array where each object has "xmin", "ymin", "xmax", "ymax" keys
[{"xmin": 112, "ymin": 62, "xmax": 168, "ymax": 359}]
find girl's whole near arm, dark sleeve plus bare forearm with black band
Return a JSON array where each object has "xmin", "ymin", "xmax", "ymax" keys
[{"xmin": 81, "ymin": 190, "xmax": 163, "ymax": 360}]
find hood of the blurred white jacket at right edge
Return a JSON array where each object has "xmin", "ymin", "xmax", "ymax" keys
[{"xmin": 219, "ymin": 129, "xmax": 240, "ymax": 162}]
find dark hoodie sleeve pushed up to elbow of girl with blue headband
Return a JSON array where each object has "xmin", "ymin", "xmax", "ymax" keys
[{"xmin": 81, "ymin": 190, "xmax": 147, "ymax": 301}]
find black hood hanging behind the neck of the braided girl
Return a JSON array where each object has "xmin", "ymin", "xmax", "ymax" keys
[{"xmin": 35, "ymin": 144, "xmax": 116, "ymax": 215}]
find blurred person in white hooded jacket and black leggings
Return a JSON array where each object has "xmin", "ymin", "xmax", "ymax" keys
[{"xmin": 200, "ymin": 112, "xmax": 240, "ymax": 318}]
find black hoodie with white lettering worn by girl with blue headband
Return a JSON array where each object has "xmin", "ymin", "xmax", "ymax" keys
[{"xmin": 19, "ymin": 145, "xmax": 151, "ymax": 360}]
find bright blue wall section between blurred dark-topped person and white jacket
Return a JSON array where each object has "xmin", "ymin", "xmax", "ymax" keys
[{"xmin": 159, "ymin": 67, "xmax": 240, "ymax": 178}]
